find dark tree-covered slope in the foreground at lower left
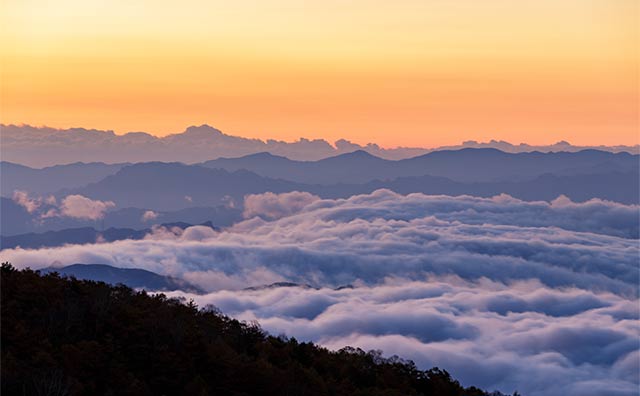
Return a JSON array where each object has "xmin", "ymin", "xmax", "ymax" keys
[{"xmin": 1, "ymin": 263, "xmax": 510, "ymax": 396}]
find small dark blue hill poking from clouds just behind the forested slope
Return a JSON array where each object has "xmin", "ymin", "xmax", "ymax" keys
[{"xmin": 40, "ymin": 264, "xmax": 203, "ymax": 293}]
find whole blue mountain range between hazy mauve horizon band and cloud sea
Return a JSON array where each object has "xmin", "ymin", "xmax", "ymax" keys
[{"xmin": 0, "ymin": 149, "xmax": 640, "ymax": 236}]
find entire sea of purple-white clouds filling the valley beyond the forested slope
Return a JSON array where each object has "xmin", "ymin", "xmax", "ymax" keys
[{"xmin": 1, "ymin": 190, "xmax": 640, "ymax": 395}]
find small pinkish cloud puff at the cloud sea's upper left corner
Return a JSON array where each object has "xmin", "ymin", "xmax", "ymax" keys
[{"xmin": 243, "ymin": 191, "xmax": 320, "ymax": 220}]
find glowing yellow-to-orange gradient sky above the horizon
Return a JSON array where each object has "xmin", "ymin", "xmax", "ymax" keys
[{"xmin": 0, "ymin": 0, "xmax": 639, "ymax": 147}]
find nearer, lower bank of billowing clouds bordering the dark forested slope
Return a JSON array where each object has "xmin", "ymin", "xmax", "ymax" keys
[{"xmin": 169, "ymin": 277, "xmax": 640, "ymax": 396}]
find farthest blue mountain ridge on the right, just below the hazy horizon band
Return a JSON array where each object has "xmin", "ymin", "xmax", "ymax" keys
[{"xmin": 201, "ymin": 149, "xmax": 640, "ymax": 185}]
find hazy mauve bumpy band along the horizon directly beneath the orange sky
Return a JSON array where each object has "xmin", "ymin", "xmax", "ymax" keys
[{"xmin": 0, "ymin": 124, "xmax": 640, "ymax": 167}]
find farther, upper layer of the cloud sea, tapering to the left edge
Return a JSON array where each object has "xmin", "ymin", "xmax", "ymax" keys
[{"xmin": 5, "ymin": 190, "xmax": 639, "ymax": 295}]
